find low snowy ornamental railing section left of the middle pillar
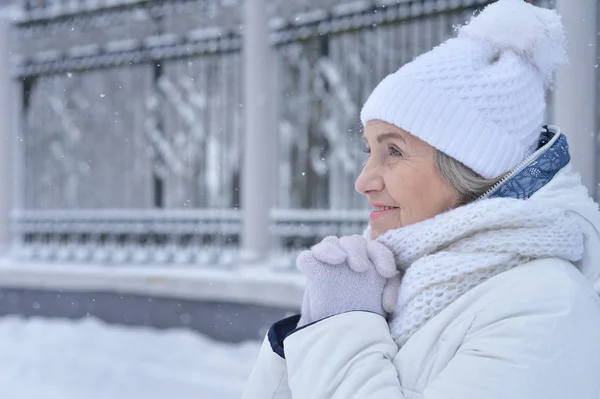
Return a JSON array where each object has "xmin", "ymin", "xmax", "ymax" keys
[{"xmin": 13, "ymin": 210, "xmax": 240, "ymax": 265}]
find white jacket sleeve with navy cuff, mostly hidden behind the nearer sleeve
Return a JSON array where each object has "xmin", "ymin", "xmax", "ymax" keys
[{"xmin": 242, "ymin": 316, "xmax": 300, "ymax": 399}]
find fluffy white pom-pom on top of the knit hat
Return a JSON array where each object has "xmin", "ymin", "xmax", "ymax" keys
[{"xmin": 458, "ymin": 0, "xmax": 567, "ymax": 87}]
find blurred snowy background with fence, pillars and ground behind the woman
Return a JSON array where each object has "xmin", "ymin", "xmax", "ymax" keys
[{"xmin": 0, "ymin": 0, "xmax": 600, "ymax": 399}]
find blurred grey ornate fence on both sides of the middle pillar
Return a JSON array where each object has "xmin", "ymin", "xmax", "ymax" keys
[{"xmin": 14, "ymin": 0, "xmax": 549, "ymax": 264}]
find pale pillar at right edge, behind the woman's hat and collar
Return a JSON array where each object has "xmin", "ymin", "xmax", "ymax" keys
[{"xmin": 553, "ymin": 0, "xmax": 599, "ymax": 196}]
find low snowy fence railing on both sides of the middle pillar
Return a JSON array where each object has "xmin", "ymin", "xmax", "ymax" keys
[{"xmin": 13, "ymin": 210, "xmax": 367, "ymax": 268}]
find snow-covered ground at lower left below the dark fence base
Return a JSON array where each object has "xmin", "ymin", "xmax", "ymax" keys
[{"xmin": 0, "ymin": 316, "xmax": 259, "ymax": 399}]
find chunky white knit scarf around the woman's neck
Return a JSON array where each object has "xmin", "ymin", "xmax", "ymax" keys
[{"xmin": 379, "ymin": 198, "xmax": 584, "ymax": 347}]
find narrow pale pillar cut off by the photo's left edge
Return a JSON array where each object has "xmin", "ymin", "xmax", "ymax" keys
[{"xmin": 0, "ymin": 18, "xmax": 15, "ymax": 254}]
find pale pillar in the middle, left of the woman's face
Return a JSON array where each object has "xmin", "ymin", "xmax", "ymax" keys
[{"xmin": 241, "ymin": 0, "xmax": 277, "ymax": 262}]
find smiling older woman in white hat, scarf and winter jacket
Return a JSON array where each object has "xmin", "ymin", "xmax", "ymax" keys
[{"xmin": 244, "ymin": 0, "xmax": 600, "ymax": 399}]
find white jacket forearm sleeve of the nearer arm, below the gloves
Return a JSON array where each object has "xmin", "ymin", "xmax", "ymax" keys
[{"xmin": 285, "ymin": 312, "xmax": 404, "ymax": 399}]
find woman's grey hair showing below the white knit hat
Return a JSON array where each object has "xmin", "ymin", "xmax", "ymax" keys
[{"xmin": 435, "ymin": 149, "xmax": 504, "ymax": 206}]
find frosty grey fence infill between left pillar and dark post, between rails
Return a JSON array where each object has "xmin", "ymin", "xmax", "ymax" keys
[{"xmin": 23, "ymin": 67, "xmax": 154, "ymax": 210}]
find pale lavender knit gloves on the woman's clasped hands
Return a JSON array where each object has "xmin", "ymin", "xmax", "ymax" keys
[{"xmin": 296, "ymin": 235, "xmax": 400, "ymax": 327}]
